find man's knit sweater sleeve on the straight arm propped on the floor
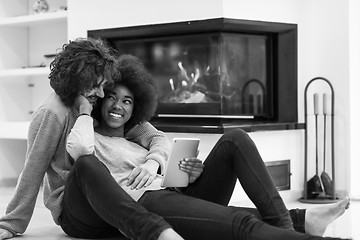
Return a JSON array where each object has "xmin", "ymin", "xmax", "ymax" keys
[{"xmin": 0, "ymin": 110, "xmax": 63, "ymax": 235}]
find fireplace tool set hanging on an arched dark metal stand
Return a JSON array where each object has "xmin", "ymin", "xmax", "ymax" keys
[{"xmin": 300, "ymin": 77, "xmax": 337, "ymax": 203}]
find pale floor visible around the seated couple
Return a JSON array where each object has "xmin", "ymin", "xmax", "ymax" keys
[{"xmin": 0, "ymin": 188, "xmax": 360, "ymax": 240}]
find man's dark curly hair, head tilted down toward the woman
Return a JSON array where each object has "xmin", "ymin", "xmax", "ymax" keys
[{"xmin": 49, "ymin": 38, "xmax": 120, "ymax": 106}]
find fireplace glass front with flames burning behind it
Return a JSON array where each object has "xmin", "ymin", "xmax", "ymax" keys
[{"xmin": 112, "ymin": 33, "xmax": 272, "ymax": 118}]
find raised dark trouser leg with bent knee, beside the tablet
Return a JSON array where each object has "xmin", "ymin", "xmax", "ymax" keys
[{"xmin": 183, "ymin": 129, "xmax": 293, "ymax": 229}]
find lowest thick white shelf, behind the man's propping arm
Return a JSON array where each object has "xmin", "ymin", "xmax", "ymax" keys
[{"xmin": 0, "ymin": 122, "xmax": 30, "ymax": 140}]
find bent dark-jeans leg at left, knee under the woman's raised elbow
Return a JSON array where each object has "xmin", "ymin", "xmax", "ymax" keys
[{"xmin": 61, "ymin": 155, "xmax": 170, "ymax": 240}]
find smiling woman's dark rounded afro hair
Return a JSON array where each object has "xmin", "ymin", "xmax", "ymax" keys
[{"xmin": 93, "ymin": 54, "xmax": 158, "ymax": 131}]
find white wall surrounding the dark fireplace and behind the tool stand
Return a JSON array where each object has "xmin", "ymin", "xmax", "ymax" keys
[{"xmin": 68, "ymin": 0, "xmax": 355, "ymax": 202}]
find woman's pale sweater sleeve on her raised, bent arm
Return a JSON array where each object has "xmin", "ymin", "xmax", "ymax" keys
[{"xmin": 66, "ymin": 115, "xmax": 94, "ymax": 161}]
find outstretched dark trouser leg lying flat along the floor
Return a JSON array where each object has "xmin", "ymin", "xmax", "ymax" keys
[{"xmin": 139, "ymin": 190, "xmax": 330, "ymax": 240}]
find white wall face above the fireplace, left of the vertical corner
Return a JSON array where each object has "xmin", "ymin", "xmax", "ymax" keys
[{"xmin": 68, "ymin": 0, "xmax": 222, "ymax": 39}]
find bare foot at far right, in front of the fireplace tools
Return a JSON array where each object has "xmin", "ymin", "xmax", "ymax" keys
[{"xmin": 305, "ymin": 197, "xmax": 350, "ymax": 236}]
